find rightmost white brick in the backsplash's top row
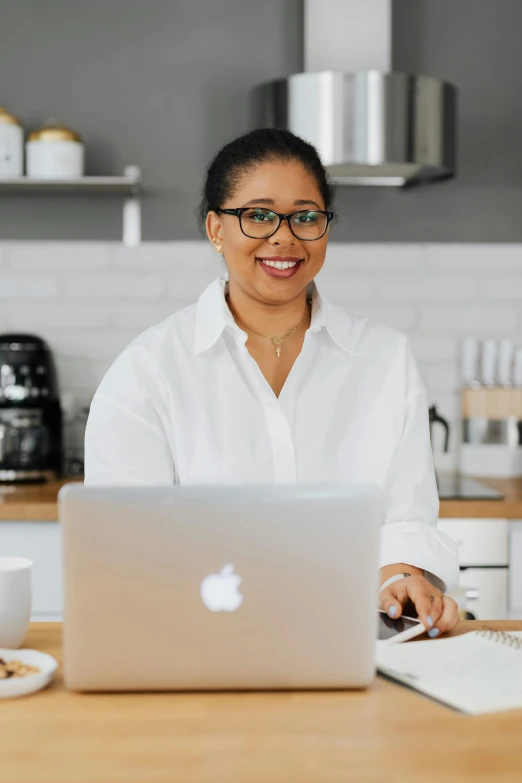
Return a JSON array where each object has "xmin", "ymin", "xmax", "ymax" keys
[{"xmin": 426, "ymin": 244, "xmax": 522, "ymax": 275}]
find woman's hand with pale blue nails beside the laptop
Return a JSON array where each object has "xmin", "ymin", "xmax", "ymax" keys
[{"xmin": 379, "ymin": 576, "xmax": 459, "ymax": 639}]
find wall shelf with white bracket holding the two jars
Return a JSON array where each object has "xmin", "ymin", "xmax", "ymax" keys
[{"xmin": 0, "ymin": 166, "xmax": 142, "ymax": 247}]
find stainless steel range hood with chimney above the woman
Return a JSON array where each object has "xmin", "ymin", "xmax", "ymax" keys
[{"xmin": 253, "ymin": 0, "xmax": 456, "ymax": 187}]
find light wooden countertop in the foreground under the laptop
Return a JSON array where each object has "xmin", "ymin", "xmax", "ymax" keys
[{"xmin": 0, "ymin": 622, "xmax": 522, "ymax": 783}]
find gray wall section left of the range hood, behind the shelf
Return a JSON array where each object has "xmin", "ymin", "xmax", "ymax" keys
[{"xmin": 0, "ymin": 0, "xmax": 302, "ymax": 240}]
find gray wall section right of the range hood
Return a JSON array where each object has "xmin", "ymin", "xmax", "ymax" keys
[{"xmin": 336, "ymin": 0, "xmax": 522, "ymax": 242}]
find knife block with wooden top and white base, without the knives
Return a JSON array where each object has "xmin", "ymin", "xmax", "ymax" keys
[{"xmin": 459, "ymin": 387, "xmax": 522, "ymax": 478}]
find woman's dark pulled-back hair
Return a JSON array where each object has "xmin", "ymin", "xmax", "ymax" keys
[{"xmin": 198, "ymin": 128, "xmax": 334, "ymax": 230}]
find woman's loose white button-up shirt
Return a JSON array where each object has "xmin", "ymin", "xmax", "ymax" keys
[{"xmin": 85, "ymin": 274, "xmax": 458, "ymax": 586}]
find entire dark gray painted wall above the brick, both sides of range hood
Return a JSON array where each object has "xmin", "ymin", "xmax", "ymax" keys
[{"xmin": 0, "ymin": 0, "xmax": 522, "ymax": 242}]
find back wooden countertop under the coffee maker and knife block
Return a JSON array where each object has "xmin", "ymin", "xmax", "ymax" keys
[{"xmin": 0, "ymin": 477, "xmax": 522, "ymax": 522}]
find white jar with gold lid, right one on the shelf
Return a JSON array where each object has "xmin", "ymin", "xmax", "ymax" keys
[{"xmin": 26, "ymin": 120, "xmax": 84, "ymax": 179}]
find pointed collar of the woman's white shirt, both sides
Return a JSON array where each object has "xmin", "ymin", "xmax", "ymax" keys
[{"xmin": 194, "ymin": 272, "xmax": 358, "ymax": 355}]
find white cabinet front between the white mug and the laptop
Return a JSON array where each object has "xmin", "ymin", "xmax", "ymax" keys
[{"xmin": 0, "ymin": 521, "xmax": 63, "ymax": 621}]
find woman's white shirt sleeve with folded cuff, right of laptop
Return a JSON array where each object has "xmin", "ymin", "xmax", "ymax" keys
[{"xmin": 380, "ymin": 348, "xmax": 459, "ymax": 591}]
